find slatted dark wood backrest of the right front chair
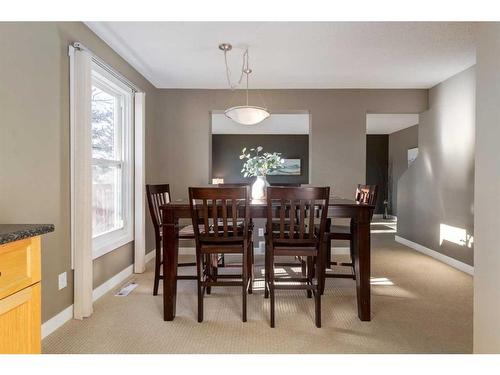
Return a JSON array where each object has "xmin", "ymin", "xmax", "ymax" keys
[{"xmin": 267, "ymin": 187, "xmax": 330, "ymax": 246}]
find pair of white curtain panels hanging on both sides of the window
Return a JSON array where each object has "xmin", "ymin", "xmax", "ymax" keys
[{"xmin": 69, "ymin": 46, "xmax": 146, "ymax": 319}]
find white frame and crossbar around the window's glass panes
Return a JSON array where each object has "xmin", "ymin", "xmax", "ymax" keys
[{"xmin": 91, "ymin": 63, "xmax": 134, "ymax": 259}]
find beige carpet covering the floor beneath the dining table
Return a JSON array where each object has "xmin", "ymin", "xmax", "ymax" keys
[{"xmin": 43, "ymin": 233, "xmax": 473, "ymax": 353}]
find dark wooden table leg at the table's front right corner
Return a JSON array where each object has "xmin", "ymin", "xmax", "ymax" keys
[{"xmin": 352, "ymin": 220, "xmax": 371, "ymax": 321}]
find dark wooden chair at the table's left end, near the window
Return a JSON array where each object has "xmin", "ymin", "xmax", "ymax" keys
[{"xmin": 146, "ymin": 184, "xmax": 196, "ymax": 296}]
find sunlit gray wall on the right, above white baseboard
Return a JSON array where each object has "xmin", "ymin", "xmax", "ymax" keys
[{"xmin": 397, "ymin": 67, "xmax": 476, "ymax": 265}]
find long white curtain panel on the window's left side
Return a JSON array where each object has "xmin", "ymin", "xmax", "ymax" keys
[{"xmin": 69, "ymin": 46, "xmax": 93, "ymax": 319}]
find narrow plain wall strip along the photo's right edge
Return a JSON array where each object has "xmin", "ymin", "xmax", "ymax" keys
[{"xmin": 474, "ymin": 23, "xmax": 500, "ymax": 353}]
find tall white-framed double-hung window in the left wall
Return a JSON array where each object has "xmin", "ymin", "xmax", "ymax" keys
[{"xmin": 91, "ymin": 64, "xmax": 134, "ymax": 258}]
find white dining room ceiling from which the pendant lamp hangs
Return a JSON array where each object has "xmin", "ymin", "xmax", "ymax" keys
[{"xmin": 87, "ymin": 22, "xmax": 475, "ymax": 88}]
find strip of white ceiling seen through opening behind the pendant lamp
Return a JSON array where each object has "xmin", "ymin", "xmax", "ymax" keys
[{"xmin": 212, "ymin": 113, "xmax": 309, "ymax": 134}]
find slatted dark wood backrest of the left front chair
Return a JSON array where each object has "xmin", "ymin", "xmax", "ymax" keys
[{"xmin": 189, "ymin": 186, "xmax": 250, "ymax": 243}]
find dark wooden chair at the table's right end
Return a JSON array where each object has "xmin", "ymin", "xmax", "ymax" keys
[{"xmin": 325, "ymin": 184, "xmax": 378, "ymax": 280}]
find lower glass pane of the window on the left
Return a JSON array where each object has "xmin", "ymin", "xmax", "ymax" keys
[{"xmin": 92, "ymin": 165, "xmax": 123, "ymax": 237}]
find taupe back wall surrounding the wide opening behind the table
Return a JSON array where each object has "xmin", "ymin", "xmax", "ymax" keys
[{"xmin": 151, "ymin": 89, "xmax": 427, "ymax": 198}]
